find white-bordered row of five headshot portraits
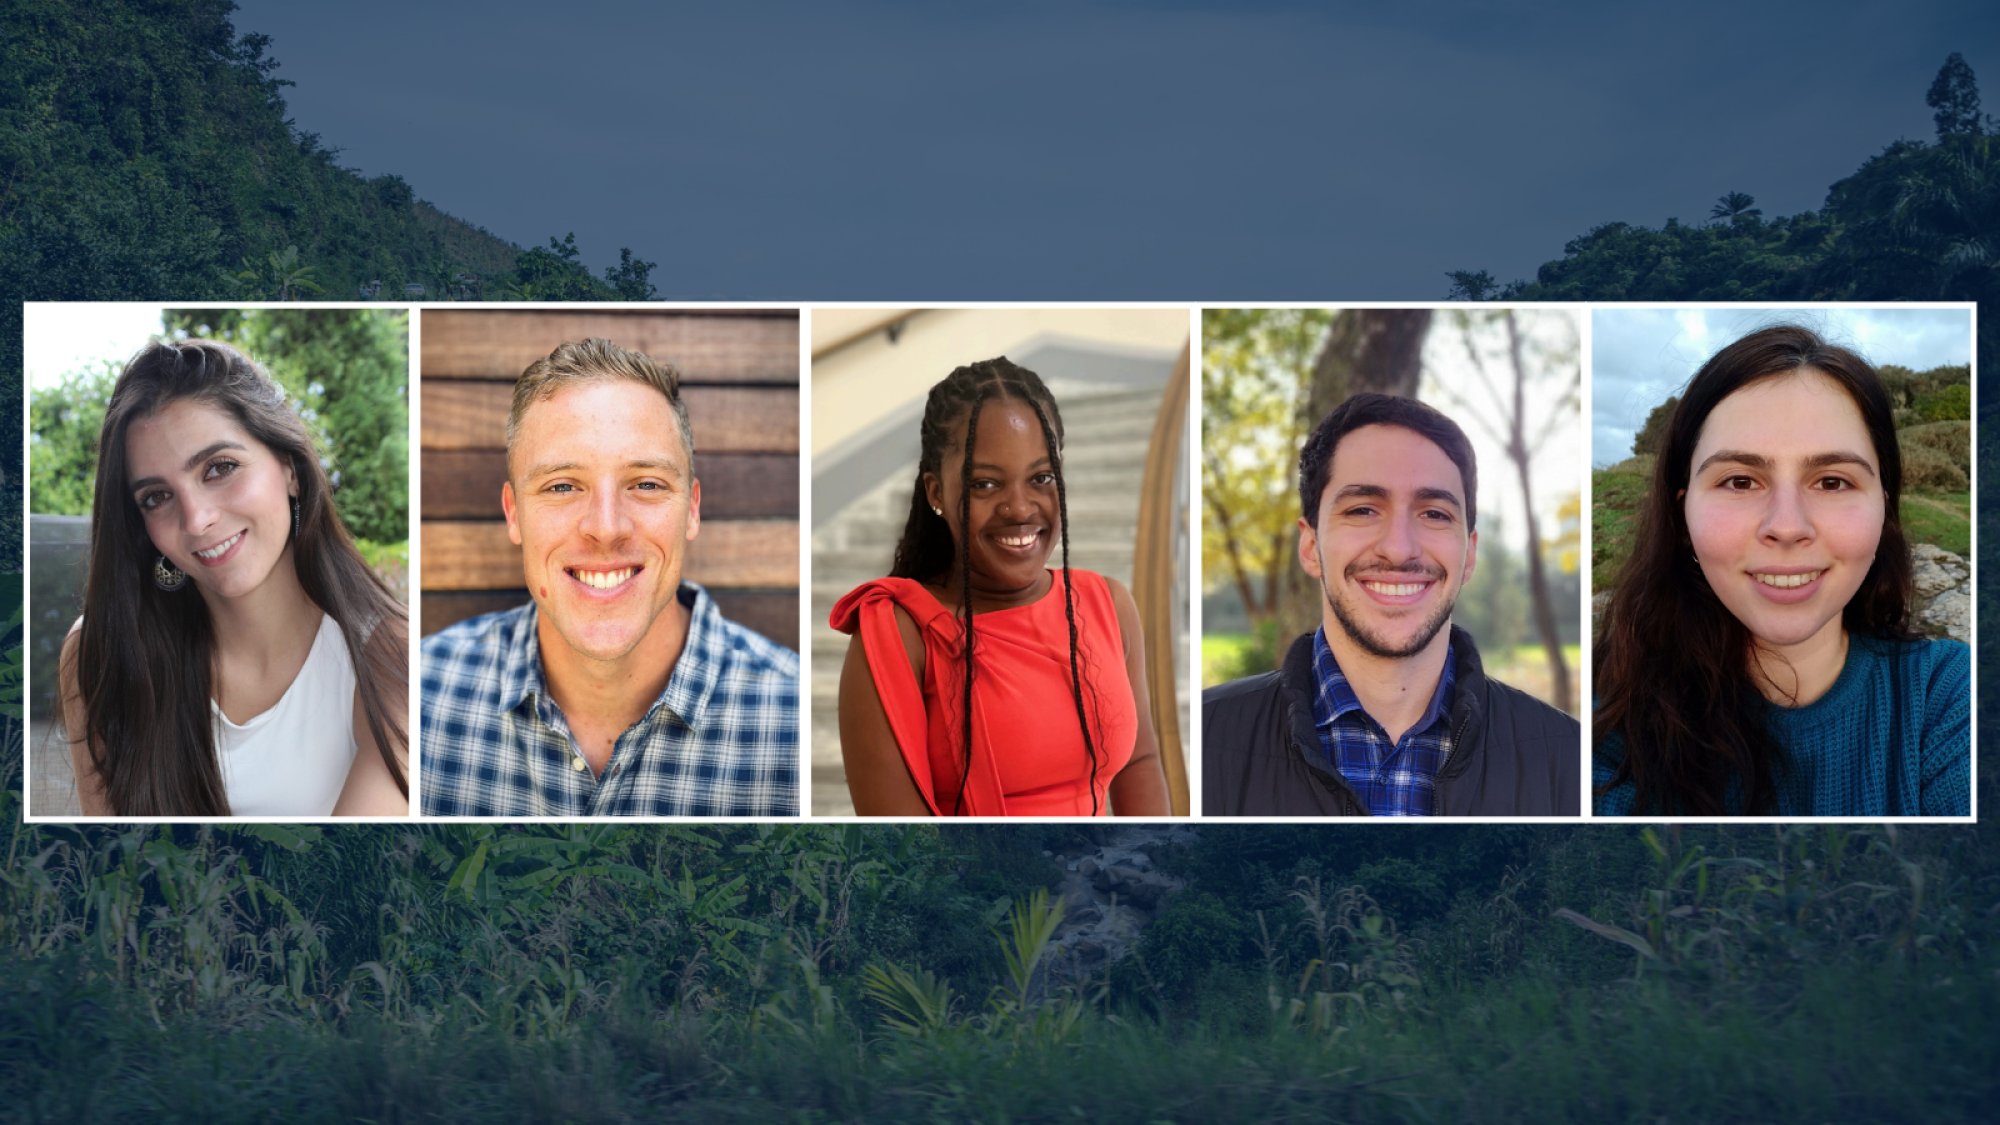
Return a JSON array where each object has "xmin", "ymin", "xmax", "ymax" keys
[{"xmin": 22, "ymin": 304, "xmax": 1978, "ymax": 821}]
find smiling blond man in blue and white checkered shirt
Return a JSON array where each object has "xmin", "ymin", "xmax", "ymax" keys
[{"xmin": 422, "ymin": 320, "xmax": 798, "ymax": 817}]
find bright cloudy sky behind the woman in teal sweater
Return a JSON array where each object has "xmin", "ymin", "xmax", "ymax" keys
[{"xmin": 1590, "ymin": 308, "xmax": 1972, "ymax": 466}]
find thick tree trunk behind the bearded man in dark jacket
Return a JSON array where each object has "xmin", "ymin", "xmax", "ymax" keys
[{"xmin": 1276, "ymin": 308, "xmax": 1430, "ymax": 665}]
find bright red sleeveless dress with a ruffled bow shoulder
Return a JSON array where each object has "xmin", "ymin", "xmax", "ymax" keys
[{"xmin": 830, "ymin": 571, "xmax": 1138, "ymax": 817}]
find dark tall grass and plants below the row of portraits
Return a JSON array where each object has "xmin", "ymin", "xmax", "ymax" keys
[{"xmin": 0, "ymin": 784, "xmax": 2000, "ymax": 1123}]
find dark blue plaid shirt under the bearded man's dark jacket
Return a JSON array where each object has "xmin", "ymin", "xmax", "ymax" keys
[{"xmin": 1312, "ymin": 629, "xmax": 1454, "ymax": 817}]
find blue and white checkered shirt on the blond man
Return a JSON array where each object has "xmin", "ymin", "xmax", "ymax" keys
[{"xmin": 420, "ymin": 583, "xmax": 798, "ymax": 817}]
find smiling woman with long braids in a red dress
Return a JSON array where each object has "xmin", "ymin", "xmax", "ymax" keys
[{"xmin": 832, "ymin": 358, "xmax": 1168, "ymax": 817}]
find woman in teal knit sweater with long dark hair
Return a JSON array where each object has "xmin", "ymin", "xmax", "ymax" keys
[{"xmin": 1592, "ymin": 326, "xmax": 1972, "ymax": 817}]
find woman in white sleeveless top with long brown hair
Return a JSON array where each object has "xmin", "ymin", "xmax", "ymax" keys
[{"xmin": 60, "ymin": 340, "xmax": 410, "ymax": 817}]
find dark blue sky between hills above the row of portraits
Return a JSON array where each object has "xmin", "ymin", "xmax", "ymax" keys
[{"xmin": 236, "ymin": 0, "xmax": 2000, "ymax": 302}]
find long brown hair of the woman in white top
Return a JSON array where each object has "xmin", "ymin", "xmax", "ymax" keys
[{"xmin": 66, "ymin": 340, "xmax": 410, "ymax": 817}]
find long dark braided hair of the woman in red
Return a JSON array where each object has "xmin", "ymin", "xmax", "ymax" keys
[{"xmin": 888, "ymin": 356, "xmax": 1098, "ymax": 817}]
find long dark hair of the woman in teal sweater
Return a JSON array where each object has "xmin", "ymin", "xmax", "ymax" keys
[{"xmin": 1592, "ymin": 324, "xmax": 1912, "ymax": 817}]
